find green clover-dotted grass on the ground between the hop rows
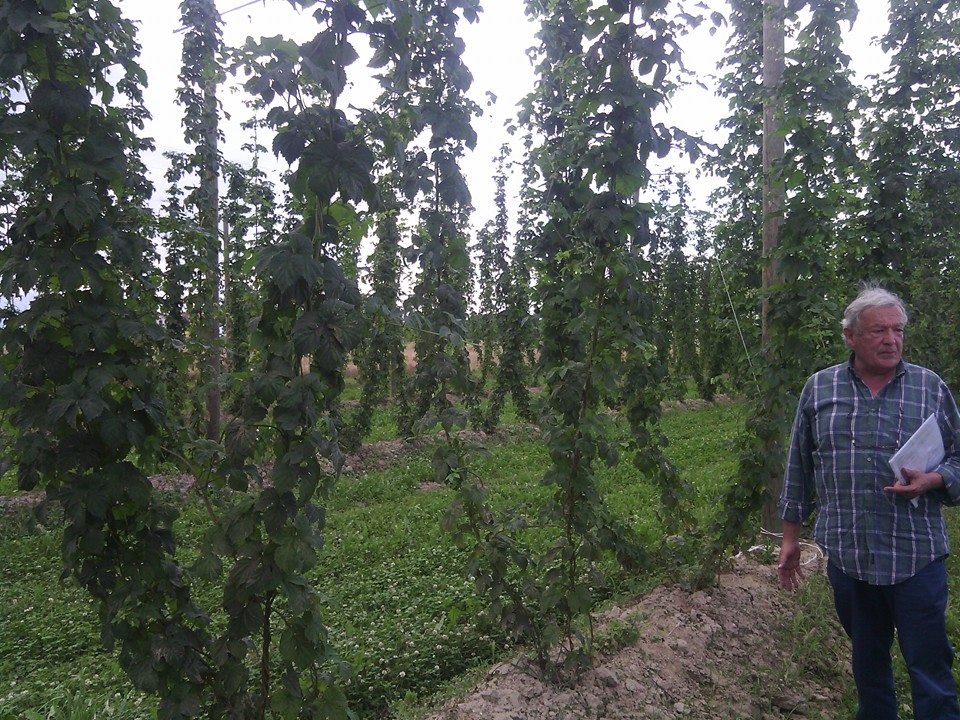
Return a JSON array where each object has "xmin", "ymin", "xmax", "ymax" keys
[{"xmin": 0, "ymin": 405, "xmax": 924, "ymax": 720}]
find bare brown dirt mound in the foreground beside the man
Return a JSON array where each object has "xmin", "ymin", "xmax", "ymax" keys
[{"xmin": 430, "ymin": 558, "xmax": 844, "ymax": 720}]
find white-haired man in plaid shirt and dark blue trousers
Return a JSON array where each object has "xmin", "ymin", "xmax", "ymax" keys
[{"xmin": 778, "ymin": 287, "xmax": 960, "ymax": 720}]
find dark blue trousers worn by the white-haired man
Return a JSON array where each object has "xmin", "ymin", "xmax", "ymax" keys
[{"xmin": 827, "ymin": 558, "xmax": 960, "ymax": 720}]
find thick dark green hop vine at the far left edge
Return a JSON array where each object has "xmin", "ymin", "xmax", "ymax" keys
[{"xmin": 0, "ymin": 0, "xmax": 214, "ymax": 718}]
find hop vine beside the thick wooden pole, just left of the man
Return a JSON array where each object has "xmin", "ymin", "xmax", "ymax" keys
[{"xmin": 698, "ymin": 2, "xmax": 856, "ymax": 583}]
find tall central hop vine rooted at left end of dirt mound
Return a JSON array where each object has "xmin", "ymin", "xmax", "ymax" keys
[{"xmin": 442, "ymin": 0, "xmax": 683, "ymax": 671}]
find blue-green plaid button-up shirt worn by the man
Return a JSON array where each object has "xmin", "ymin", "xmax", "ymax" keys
[{"xmin": 779, "ymin": 358, "xmax": 960, "ymax": 585}]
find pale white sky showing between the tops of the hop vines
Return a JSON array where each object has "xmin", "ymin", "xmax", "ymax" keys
[{"xmin": 120, "ymin": 0, "xmax": 886, "ymax": 242}]
